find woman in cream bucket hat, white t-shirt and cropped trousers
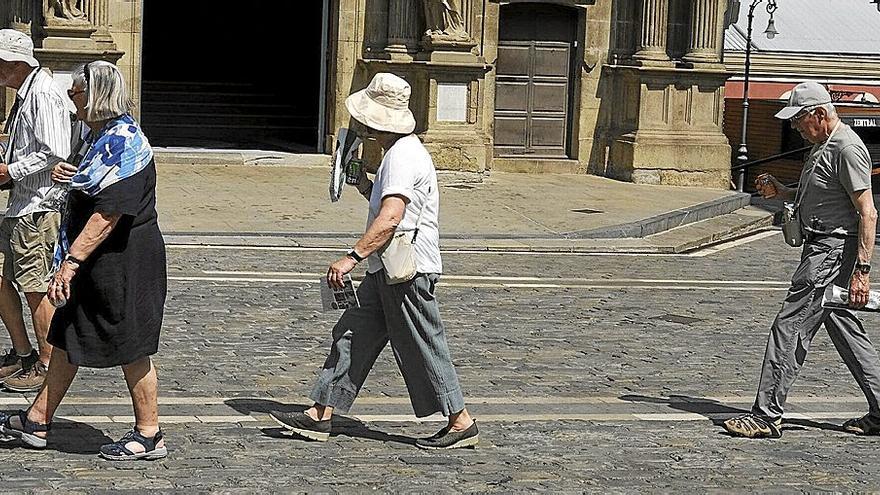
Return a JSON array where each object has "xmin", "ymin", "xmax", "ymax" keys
[{"xmin": 272, "ymin": 73, "xmax": 479, "ymax": 449}]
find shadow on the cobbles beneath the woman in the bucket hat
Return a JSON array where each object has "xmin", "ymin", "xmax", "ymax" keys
[{"xmin": 224, "ymin": 399, "xmax": 416, "ymax": 445}]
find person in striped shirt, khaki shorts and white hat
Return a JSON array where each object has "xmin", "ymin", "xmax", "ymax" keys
[{"xmin": 0, "ymin": 29, "xmax": 72, "ymax": 392}]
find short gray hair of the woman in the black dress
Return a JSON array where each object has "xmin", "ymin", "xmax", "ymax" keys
[{"xmin": 71, "ymin": 60, "xmax": 134, "ymax": 122}]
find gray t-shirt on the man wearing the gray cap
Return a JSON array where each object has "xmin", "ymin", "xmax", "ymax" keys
[{"xmin": 800, "ymin": 123, "xmax": 871, "ymax": 236}]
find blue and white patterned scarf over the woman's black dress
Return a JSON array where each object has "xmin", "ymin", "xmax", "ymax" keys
[{"xmin": 52, "ymin": 115, "xmax": 153, "ymax": 274}]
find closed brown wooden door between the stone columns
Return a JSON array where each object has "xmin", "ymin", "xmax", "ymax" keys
[{"xmin": 495, "ymin": 3, "xmax": 578, "ymax": 158}]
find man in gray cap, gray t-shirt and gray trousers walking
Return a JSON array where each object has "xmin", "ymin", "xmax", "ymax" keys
[{"xmin": 724, "ymin": 82, "xmax": 880, "ymax": 438}]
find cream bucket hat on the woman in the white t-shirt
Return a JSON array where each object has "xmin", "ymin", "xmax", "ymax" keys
[{"xmin": 345, "ymin": 72, "xmax": 416, "ymax": 134}]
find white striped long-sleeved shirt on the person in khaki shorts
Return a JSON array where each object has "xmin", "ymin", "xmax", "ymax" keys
[{"xmin": 5, "ymin": 69, "xmax": 71, "ymax": 217}]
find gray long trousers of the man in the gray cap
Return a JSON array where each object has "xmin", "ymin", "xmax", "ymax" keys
[{"xmin": 752, "ymin": 236, "xmax": 880, "ymax": 420}]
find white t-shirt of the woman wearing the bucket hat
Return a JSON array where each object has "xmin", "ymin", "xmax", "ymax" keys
[{"xmin": 367, "ymin": 134, "xmax": 443, "ymax": 273}]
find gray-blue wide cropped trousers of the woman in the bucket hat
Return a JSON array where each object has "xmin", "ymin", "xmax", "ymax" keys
[{"xmin": 309, "ymin": 271, "xmax": 464, "ymax": 417}]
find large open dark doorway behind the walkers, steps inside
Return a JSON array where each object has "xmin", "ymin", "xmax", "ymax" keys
[{"xmin": 141, "ymin": 0, "xmax": 324, "ymax": 151}]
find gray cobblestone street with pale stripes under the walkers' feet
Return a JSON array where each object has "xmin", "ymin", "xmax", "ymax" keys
[{"xmin": 0, "ymin": 235, "xmax": 880, "ymax": 493}]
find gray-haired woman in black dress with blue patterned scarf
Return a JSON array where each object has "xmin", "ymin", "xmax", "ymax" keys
[{"xmin": 0, "ymin": 62, "xmax": 167, "ymax": 460}]
